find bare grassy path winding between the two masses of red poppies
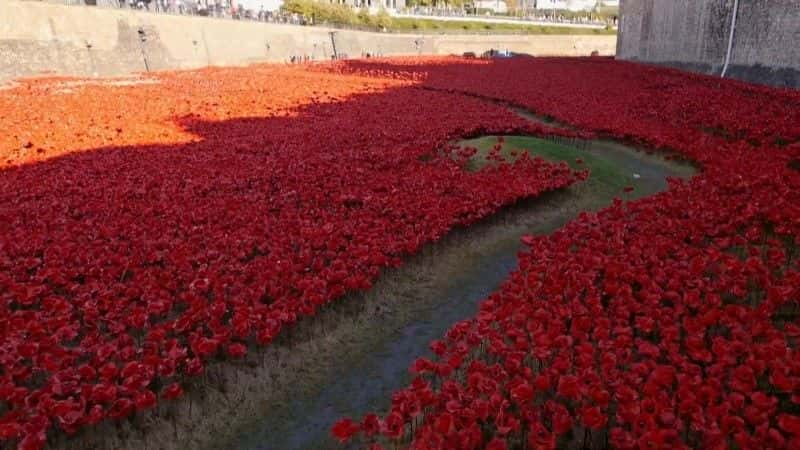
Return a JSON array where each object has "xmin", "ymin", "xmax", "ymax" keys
[{"xmin": 233, "ymin": 136, "xmax": 691, "ymax": 450}]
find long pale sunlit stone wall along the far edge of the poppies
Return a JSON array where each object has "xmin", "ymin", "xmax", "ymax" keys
[{"xmin": 0, "ymin": 0, "xmax": 616, "ymax": 81}]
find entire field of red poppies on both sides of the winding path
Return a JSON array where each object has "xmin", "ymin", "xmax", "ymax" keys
[{"xmin": 0, "ymin": 59, "xmax": 800, "ymax": 449}]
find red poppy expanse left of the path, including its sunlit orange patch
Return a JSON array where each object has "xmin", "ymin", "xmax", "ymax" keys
[{"xmin": 0, "ymin": 66, "xmax": 585, "ymax": 449}]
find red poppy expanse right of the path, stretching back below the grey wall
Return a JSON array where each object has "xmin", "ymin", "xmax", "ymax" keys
[{"xmin": 320, "ymin": 58, "xmax": 800, "ymax": 450}]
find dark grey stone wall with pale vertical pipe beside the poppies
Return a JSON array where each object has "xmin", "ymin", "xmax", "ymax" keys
[{"xmin": 617, "ymin": 0, "xmax": 800, "ymax": 87}]
